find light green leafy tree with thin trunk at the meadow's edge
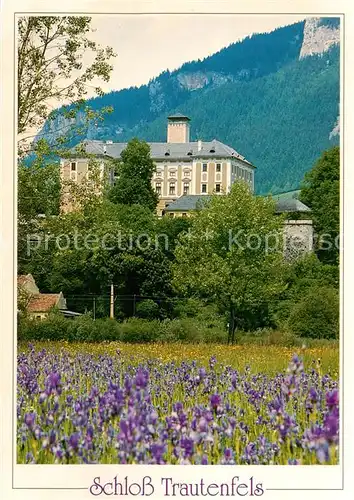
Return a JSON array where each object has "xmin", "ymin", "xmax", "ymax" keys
[{"xmin": 173, "ymin": 182, "xmax": 284, "ymax": 339}]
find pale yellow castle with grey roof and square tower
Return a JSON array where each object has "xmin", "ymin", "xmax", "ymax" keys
[{"xmin": 61, "ymin": 114, "xmax": 255, "ymax": 215}]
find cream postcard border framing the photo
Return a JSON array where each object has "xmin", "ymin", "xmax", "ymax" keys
[{"xmin": 0, "ymin": 0, "xmax": 354, "ymax": 499}]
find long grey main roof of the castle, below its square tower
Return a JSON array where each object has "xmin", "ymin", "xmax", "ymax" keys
[{"xmin": 78, "ymin": 139, "xmax": 255, "ymax": 168}]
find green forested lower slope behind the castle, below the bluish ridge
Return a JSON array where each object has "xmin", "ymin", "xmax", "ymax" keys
[{"xmin": 129, "ymin": 47, "xmax": 339, "ymax": 193}]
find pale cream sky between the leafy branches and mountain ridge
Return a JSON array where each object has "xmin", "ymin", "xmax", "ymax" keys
[{"xmin": 91, "ymin": 14, "xmax": 304, "ymax": 91}]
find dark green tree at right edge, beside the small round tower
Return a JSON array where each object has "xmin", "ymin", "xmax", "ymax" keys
[{"xmin": 300, "ymin": 146, "xmax": 340, "ymax": 264}]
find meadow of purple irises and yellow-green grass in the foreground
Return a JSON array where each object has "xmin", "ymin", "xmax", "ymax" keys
[{"xmin": 17, "ymin": 342, "xmax": 339, "ymax": 465}]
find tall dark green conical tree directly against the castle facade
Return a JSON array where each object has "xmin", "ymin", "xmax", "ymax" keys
[{"xmin": 109, "ymin": 139, "xmax": 158, "ymax": 211}]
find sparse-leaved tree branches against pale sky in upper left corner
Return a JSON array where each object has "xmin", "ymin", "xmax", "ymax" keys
[{"xmin": 18, "ymin": 16, "xmax": 115, "ymax": 138}]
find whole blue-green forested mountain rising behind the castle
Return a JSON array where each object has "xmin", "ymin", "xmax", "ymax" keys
[{"xmin": 40, "ymin": 18, "xmax": 339, "ymax": 193}]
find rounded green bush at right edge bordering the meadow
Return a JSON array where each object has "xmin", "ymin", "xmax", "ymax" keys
[{"xmin": 288, "ymin": 287, "xmax": 339, "ymax": 339}]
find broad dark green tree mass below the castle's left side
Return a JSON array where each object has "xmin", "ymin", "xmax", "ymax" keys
[{"xmin": 21, "ymin": 197, "xmax": 172, "ymax": 316}]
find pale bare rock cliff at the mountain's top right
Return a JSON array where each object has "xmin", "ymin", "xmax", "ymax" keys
[{"xmin": 300, "ymin": 17, "xmax": 340, "ymax": 59}]
